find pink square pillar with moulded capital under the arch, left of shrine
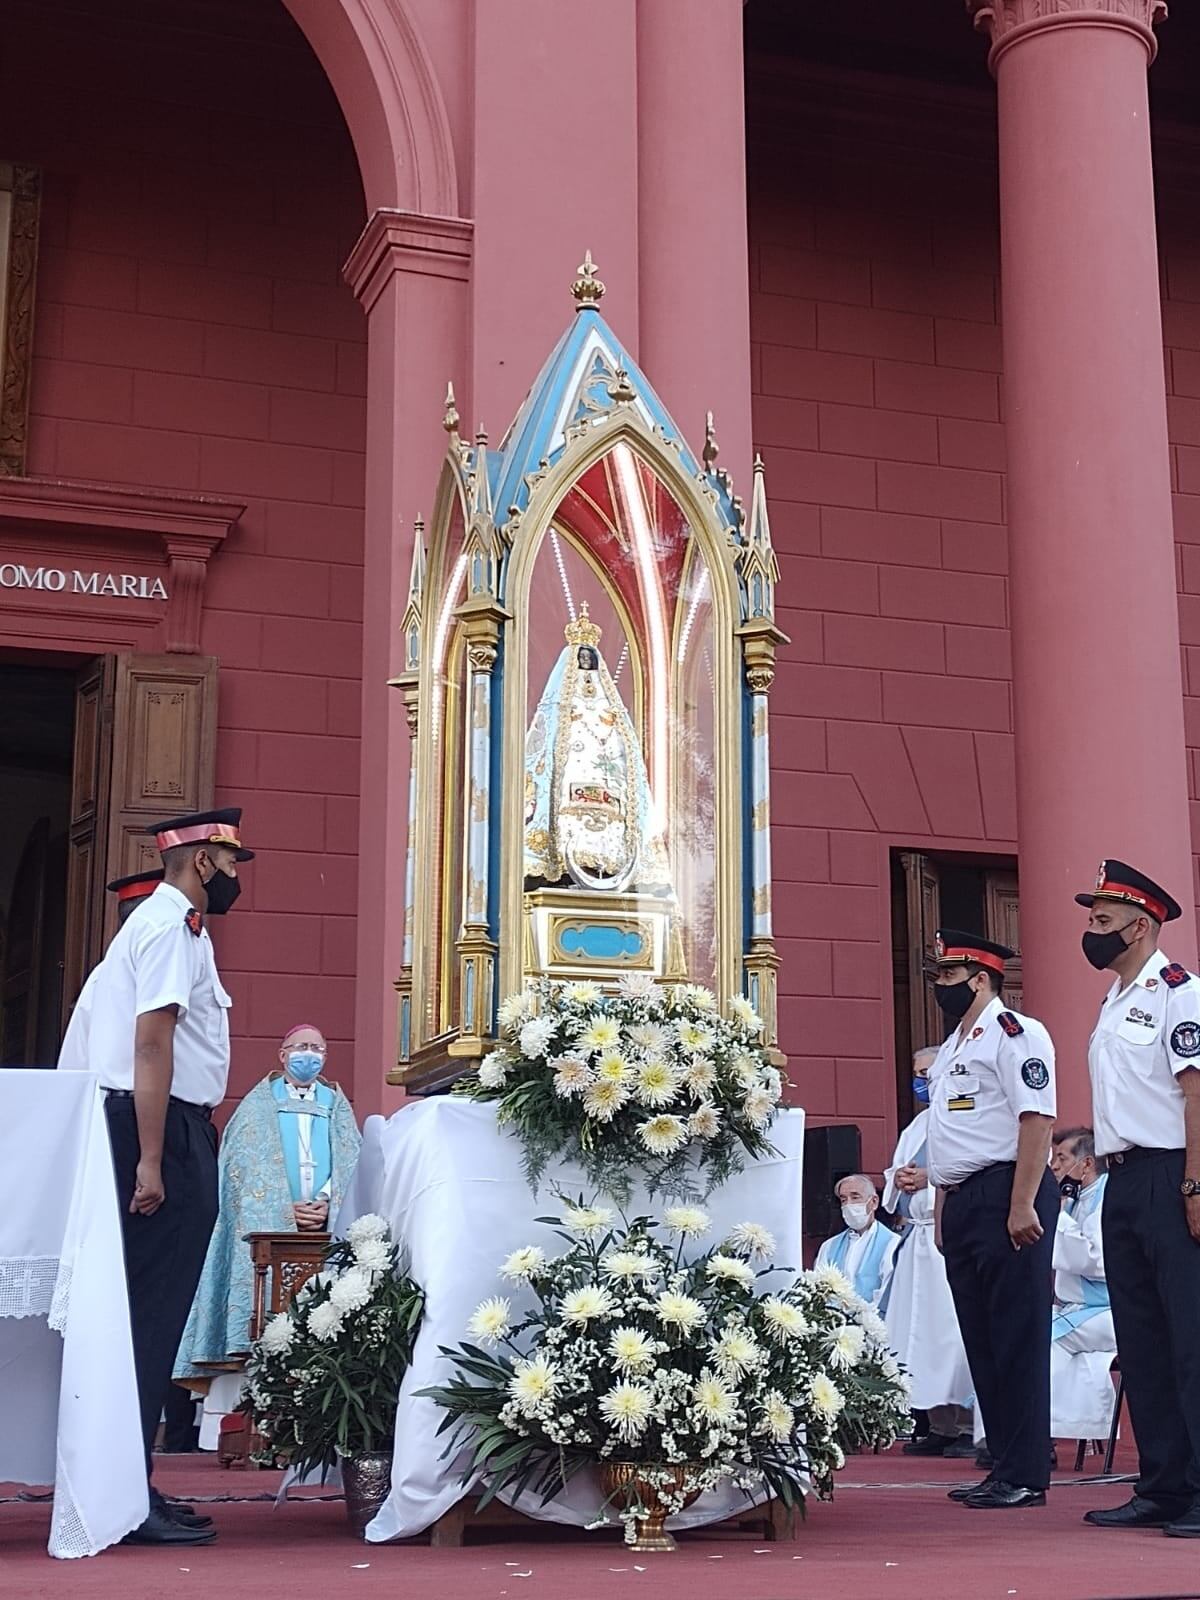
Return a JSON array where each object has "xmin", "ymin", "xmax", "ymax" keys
[{"xmin": 346, "ymin": 210, "xmax": 472, "ymax": 1118}]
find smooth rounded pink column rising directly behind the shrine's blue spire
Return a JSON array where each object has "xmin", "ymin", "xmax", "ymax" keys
[{"xmin": 640, "ymin": 0, "xmax": 754, "ymax": 489}]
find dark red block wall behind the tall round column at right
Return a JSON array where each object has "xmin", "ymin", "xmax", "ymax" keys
[{"xmin": 750, "ymin": 93, "xmax": 1200, "ymax": 1171}]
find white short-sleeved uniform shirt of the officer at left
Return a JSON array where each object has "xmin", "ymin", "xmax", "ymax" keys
[{"xmin": 59, "ymin": 883, "xmax": 232, "ymax": 1106}]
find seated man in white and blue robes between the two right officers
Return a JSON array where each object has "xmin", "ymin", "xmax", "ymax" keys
[{"xmin": 1050, "ymin": 1128, "xmax": 1117, "ymax": 1438}]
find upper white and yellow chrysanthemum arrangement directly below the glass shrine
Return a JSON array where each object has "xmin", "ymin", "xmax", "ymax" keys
[{"xmin": 456, "ymin": 974, "xmax": 782, "ymax": 1202}]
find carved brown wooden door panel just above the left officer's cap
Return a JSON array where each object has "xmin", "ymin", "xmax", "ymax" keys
[{"xmin": 104, "ymin": 654, "xmax": 218, "ymax": 938}]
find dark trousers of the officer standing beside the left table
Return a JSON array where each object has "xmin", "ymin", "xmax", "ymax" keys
[{"xmin": 104, "ymin": 1094, "xmax": 218, "ymax": 1478}]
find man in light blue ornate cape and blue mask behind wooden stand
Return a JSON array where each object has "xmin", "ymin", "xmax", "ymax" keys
[{"xmin": 174, "ymin": 1022, "xmax": 362, "ymax": 1450}]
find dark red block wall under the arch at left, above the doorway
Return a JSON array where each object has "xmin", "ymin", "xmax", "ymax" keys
[{"xmin": 0, "ymin": 0, "xmax": 365, "ymax": 1093}]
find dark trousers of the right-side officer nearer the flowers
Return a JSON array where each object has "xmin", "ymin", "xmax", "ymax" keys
[{"xmin": 942, "ymin": 1162, "xmax": 1059, "ymax": 1490}]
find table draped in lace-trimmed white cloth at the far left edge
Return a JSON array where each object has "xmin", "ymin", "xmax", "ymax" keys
[{"xmin": 0, "ymin": 1069, "xmax": 149, "ymax": 1557}]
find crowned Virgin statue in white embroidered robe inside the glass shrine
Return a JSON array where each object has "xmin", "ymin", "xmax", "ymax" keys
[{"xmin": 525, "ymin": 605, "xmax": 670, "ymax": 893}]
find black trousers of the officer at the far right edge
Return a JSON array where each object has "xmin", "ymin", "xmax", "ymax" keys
[{"xmin": 1101, "ymin": 1150, "xmax": 1200, "ymax": 1510}]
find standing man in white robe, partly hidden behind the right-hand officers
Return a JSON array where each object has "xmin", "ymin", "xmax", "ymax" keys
[{"xmin": 883, "ymin": 1050, "xmax": 974, "ymax": 1458}]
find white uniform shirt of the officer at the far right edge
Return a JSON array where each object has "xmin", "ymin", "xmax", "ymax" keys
[{"xmin": 1088, "ymin": 950, "xmax": 1200, "ymax": 1155}]
